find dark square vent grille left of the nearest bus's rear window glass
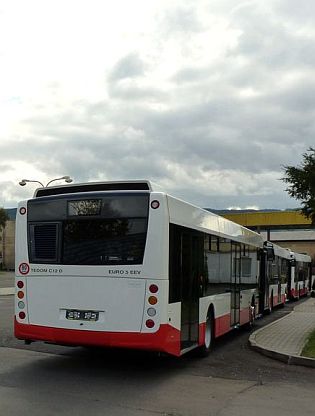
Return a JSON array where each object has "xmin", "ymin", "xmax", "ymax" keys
[{"xmin": 30, "ymin": 223, "xmax": 59, "ymax": 262}]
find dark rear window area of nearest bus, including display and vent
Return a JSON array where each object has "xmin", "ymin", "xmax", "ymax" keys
[{"xmin": 28, "ymin": 194, "xmax": 149, "ymax": 265}]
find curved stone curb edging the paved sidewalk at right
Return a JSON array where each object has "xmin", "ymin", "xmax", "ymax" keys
[{"xmin": 248, "ymin": 312, "xmax": 315, "ymax": 368}]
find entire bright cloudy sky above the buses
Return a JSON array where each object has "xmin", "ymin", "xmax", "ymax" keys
[{"xmin": 0, "ymin": 0, "xmax": 315, "ymax": 209}]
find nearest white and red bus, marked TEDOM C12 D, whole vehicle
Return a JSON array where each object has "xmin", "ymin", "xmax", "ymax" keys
[{"xmin": 15, "ymin": 181, "xmax": 263, "ymax": 356}]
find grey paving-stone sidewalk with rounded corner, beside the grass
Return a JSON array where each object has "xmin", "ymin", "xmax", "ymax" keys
[{"xmin": 249, "ymin": 298, "xmax": 315, "ymax": 367}]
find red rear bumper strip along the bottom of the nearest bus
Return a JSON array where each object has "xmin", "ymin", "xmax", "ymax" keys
[{"xmin": 14, "ymin": 319, "xmax": 180, "ymax": 356}]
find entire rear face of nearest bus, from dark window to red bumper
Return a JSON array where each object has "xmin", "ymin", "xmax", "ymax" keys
[{"xmin": 15, "ymin": 191, "xmax": 183, "ymax": 355}]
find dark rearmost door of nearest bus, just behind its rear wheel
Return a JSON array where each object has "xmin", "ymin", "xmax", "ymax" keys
[{"xmin": 181, "ymin": 230, "xmax": 204, "ymax": 350}]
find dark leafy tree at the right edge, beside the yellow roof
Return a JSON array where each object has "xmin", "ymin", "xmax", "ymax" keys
[{"xmin": 281, "ymin": 147, "xmax": 315, "ymax": 224}]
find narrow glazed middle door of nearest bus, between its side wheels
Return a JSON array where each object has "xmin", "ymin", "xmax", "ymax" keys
[{"xmin": 231, "ymin": 242, "xmax": 241, "ymax": 326}]
